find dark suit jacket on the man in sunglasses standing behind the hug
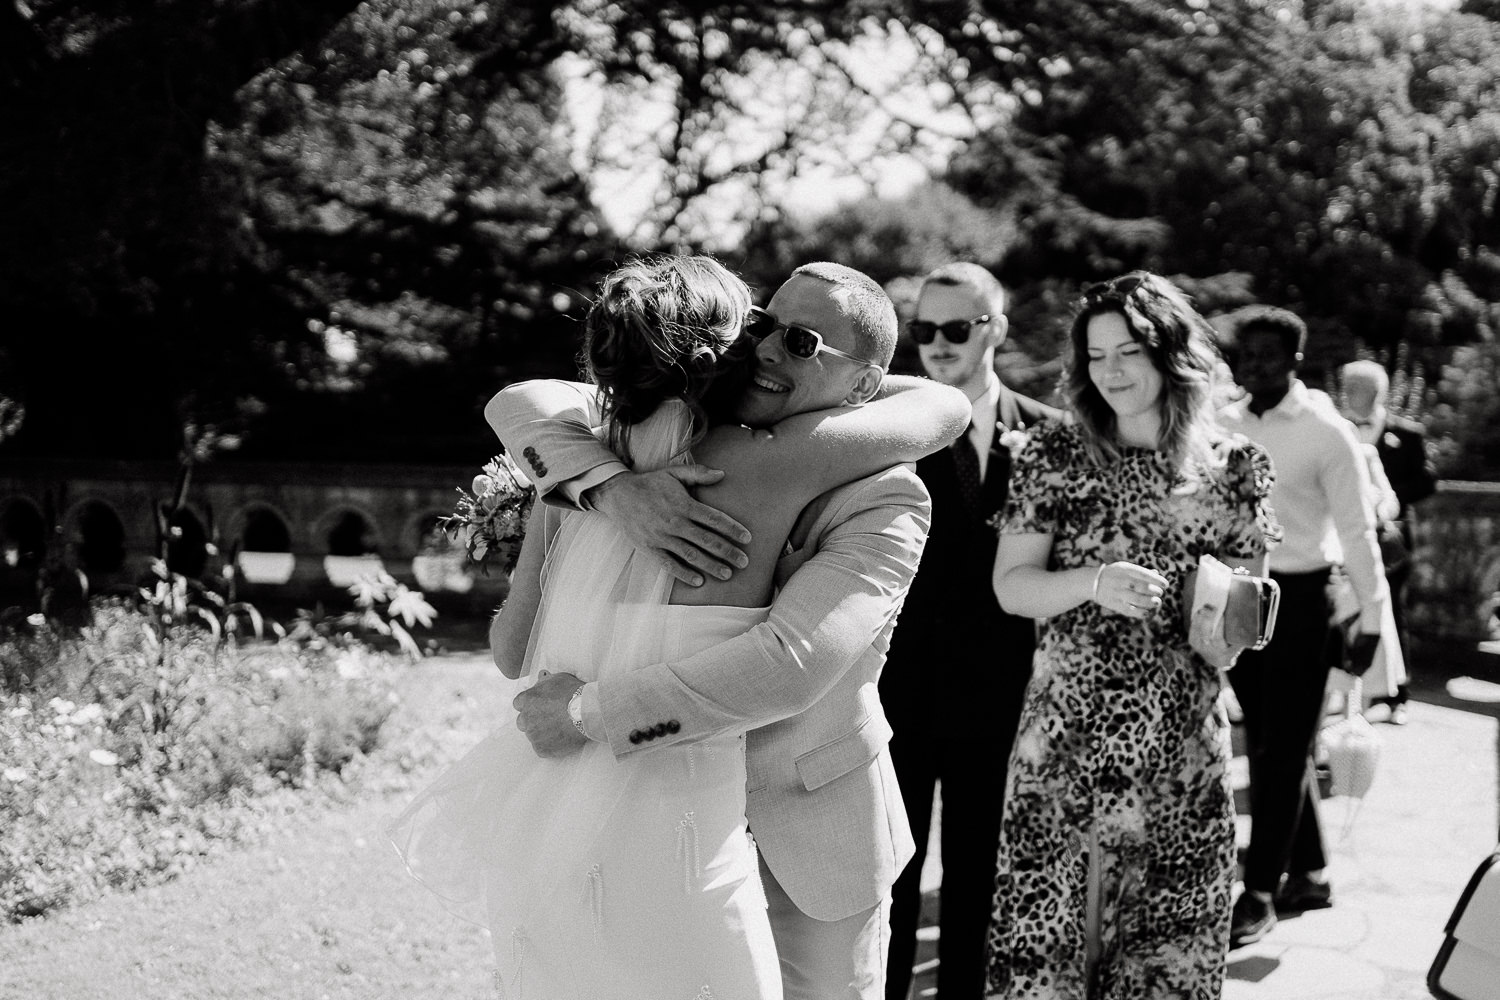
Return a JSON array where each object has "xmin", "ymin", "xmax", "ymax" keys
[{"xmin": 881, "ymin": 385, "xmax": 1061, "ymax": 739}]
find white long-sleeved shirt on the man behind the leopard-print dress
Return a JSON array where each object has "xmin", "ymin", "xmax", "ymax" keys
[{"xmin": 1220, "ymin": 379, "xmax": 1389, "ymax": 633}]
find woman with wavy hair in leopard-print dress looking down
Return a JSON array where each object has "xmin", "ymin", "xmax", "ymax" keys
[{"xmin": 989, "ymin": 271, "xmax": 1280, "ymax": 1000}]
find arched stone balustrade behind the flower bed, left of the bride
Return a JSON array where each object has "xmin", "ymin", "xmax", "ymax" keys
[{"xmin": 0, "ymin": 460, "xmax": 507, "ymax": 607}]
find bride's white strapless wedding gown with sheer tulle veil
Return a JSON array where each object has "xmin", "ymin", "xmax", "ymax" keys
[{"xmin": 390, "ymin": 403, "xmax": 782, "ymax": 1000}]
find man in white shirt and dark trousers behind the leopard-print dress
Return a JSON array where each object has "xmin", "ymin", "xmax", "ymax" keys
[{"xmin": 1221, "ymin": 307, "xmax": 1389, "ymax": 948}]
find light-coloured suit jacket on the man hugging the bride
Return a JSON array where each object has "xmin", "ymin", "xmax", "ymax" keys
[{"xmin": 485, "ymin": 382, "xmax": 930, "ymax": 921}]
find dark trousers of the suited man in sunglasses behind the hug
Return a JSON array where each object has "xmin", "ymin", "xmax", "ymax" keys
[{"xmin": 885, "ymin": 731, "xmax": 1016, "ymax": 1000}]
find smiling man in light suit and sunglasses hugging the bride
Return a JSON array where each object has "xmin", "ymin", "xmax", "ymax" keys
[{"xmin": 485, "ymin": 264, "xmax": 929, "ymax": 1000}]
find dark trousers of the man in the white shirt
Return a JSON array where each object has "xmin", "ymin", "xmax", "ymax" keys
[{"xmin": 1229, "ymin": 570, "xmax": 1329, "ymax": 892}]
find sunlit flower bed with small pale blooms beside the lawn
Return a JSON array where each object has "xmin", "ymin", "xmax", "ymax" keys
[{"xmin": 0, "ymin": 601, "xmax": 417, "ymax": 921}]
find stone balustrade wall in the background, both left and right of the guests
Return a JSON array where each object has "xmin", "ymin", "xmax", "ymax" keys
[{"xmin": 0, "ymin": 462, "xmax": 1500, "ymax": 643}]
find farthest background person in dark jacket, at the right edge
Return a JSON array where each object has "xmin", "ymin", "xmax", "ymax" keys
[{"xmin": 1341, "ymin": 361, "xmax": 1437, "ymax": 726}]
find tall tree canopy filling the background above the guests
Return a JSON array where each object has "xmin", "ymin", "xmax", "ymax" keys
[{"xmin": 0, "ymin": 0, "xmax": 1500, "ymax": 475}]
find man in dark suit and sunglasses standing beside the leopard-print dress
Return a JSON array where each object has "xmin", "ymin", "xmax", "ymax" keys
[{"xmin": 881, "ymin": 264, "xmax": 1061, "ymax": 1000}]
